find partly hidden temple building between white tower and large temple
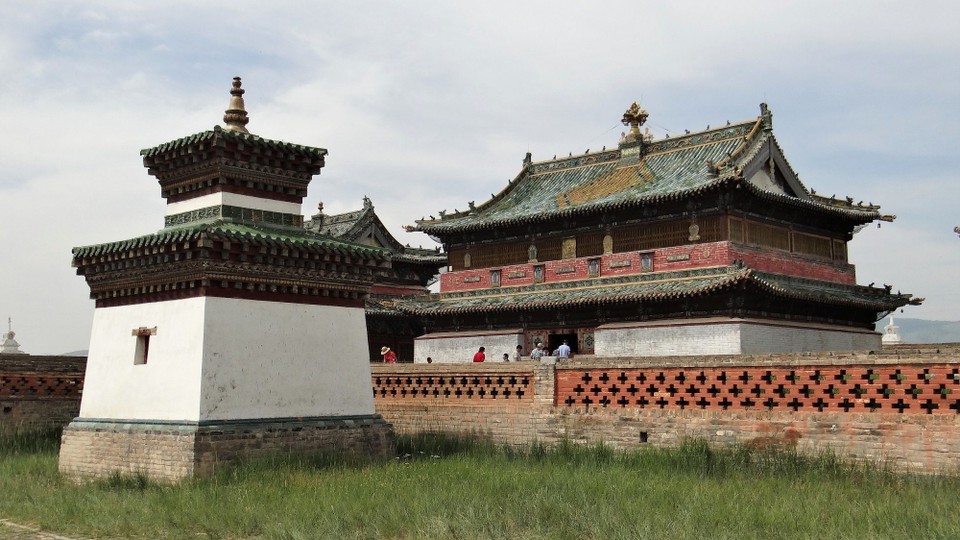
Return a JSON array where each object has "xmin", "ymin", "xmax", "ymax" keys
[{"xmin": 304, "ymin": 197, "xmax": 447, "ymax": 362}]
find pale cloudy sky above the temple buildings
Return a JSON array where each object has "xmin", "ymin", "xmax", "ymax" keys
[{"xmin": 0, "ymin": 0, "xmax": 960, "ymax": 354}]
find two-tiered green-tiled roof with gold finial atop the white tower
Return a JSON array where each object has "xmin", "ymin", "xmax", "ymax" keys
[{"xmin": 73, "ymin": 78, "xmax": 389, "ymax": 307}]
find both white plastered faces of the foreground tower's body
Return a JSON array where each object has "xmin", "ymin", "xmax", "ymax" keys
[{"xmin": 80, "ymin": 297, "xmax": 374, "ymax": 421}]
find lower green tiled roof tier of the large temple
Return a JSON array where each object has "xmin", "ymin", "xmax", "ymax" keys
[{"xmin": 396, "ymin": 265, "xmax": 914, "ymax": 315}]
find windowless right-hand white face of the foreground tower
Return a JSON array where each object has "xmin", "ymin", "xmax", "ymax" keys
[{"xmin": 200, "ymin": 298, "xmax": 374, "ymax": 420}]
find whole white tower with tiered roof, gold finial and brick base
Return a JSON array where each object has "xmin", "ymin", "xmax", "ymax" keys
[{"xmin": 60, "ymin": 78, "xmax": 392, "ymax": 480}]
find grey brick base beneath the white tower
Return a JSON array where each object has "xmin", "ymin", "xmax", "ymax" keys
[{"xmin": 60, "ymin": 415, "xmax": 394, "ymax": 482}]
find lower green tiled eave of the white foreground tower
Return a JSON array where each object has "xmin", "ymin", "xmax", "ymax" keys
[{"xmin": 73, "ymin": 221, "xmax": 386, "ymax": 261}]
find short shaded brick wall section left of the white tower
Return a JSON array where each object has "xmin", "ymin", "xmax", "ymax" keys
[{"xmin": 0, "ymin": 355, "xmax": 86, "ymax": 435}]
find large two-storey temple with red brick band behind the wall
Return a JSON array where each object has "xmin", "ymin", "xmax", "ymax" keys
[{"xmin": 397, "ymin": 103, "xmax": 922, "ymax": 362}]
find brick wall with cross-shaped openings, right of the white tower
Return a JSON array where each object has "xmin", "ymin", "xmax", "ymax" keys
[{"xmin": 373, "ymin": 346, "xmax": 960, "ymax": 471}]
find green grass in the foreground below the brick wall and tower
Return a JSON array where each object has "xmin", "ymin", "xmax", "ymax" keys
[{"xmin": 0, "ymin": 434, "xmax": 960, "ymax": 539}]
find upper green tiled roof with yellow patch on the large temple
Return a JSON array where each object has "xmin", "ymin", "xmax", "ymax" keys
[{"xmin": 411, "ymin": 117, "xmax": 879, "ymax": 234}]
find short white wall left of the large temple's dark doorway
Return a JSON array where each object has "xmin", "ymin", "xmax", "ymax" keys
[{"xmin": 413, "ymin": 330, "xmax": 516, "ymax": 364}]
